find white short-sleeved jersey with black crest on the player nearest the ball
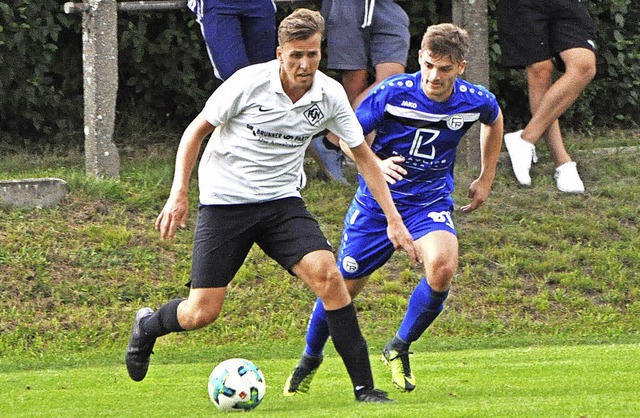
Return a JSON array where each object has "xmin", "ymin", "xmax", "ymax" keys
[{"xmin": 198, "ymin": 60, "xmax": 364, "ymax": 205}]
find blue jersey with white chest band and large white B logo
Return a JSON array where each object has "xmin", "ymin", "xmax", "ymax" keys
[{"xmin": 355, "ymin": 72, "xmax": 500, "ymax": 212}]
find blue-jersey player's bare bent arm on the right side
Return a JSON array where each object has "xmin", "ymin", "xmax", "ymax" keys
[{"xmin": 460, "ymin": 111, "xmax": 503, "ymax": 213}]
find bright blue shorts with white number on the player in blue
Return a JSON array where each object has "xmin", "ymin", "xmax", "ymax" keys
[{"xmin": 337, "ymin": 199, "xmax": 457, "ymax": 279}]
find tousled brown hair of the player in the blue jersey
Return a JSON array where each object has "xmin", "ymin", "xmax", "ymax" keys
[{"xmin": 420, "ymin": 23, "xmax": 469, "ymax": 63}]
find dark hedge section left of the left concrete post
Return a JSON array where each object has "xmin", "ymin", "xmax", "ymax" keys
[{"xmin": 0, "ymin": 0, "xmax": 82, "ymax": 145}]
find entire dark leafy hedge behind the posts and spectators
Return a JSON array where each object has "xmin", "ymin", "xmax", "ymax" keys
[{"xmin": 0, "ymin": 0, "xmax": 640, "ymax": 152}]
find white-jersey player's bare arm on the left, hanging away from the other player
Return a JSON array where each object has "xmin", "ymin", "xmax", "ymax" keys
[{"xmin": 156, "ymin": 113, "xmax": 215, "ymax": 239}]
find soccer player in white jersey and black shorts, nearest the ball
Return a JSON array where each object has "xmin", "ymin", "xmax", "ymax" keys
[{"xmin": 125, "ymin": 9, "xmax": 418, "ymax": 402}]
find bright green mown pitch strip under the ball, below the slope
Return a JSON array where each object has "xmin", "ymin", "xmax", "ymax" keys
[{"xmin": 0, "ymin": 344, "xmax": 640, "ymax": 418}]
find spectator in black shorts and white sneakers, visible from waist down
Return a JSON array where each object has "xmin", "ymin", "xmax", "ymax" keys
[{"xmin": 498, "ymin": 0, "xmax": 596, "ymax": 193}]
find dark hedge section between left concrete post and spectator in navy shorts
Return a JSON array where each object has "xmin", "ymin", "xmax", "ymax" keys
[{"xmin": 117, "ymin": 9, "xmax": 219, "ymax": 132}]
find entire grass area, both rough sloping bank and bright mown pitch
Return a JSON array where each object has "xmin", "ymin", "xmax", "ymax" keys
[{"xmin": 0, "ymin": 127, "xmax": 640, "ymax": 418}]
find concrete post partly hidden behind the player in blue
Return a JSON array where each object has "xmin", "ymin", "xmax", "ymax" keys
[{"xmin": 452, "ymin": 0, "xmax": 489, "ymax": 168}]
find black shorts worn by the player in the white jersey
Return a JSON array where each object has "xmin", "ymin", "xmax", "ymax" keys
[{"xmin": 187, "ymin": 197, "xmax": 332, "ymax": 288}]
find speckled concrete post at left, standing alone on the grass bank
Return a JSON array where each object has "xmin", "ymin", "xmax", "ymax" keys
[{"xmin": 82, "ymin": 0, "xmax": 120, "ymax": 178}]
